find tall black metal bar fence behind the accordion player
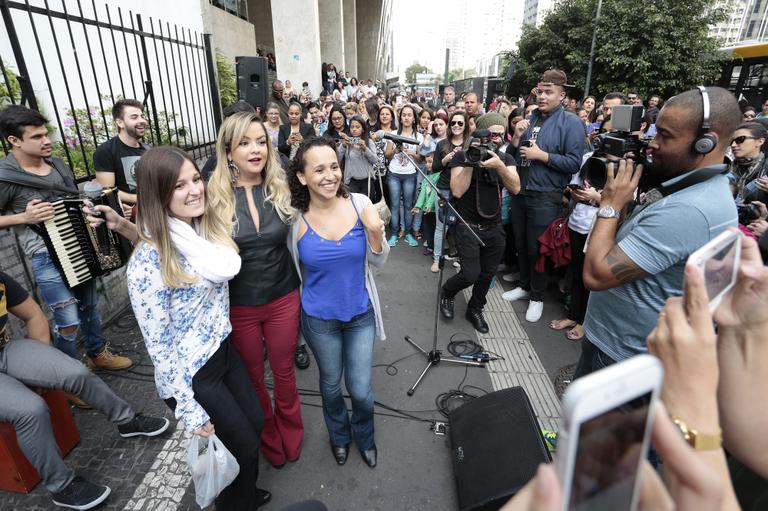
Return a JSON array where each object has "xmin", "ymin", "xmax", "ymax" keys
[{"xmin": 0, "ymin": 0, "xmax": 221, "ymax": 181}]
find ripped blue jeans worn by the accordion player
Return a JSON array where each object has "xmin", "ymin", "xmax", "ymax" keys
[{"xmin": 32, "ymin": 250, "xmax": 104, "ymax": 358}]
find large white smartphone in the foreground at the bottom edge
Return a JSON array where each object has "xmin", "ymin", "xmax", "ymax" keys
[{"xmin": 555, "ymin": 355, "xmax": 664, "ymax": 511}]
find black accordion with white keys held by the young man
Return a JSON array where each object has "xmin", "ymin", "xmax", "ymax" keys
[{"xmin": 40, "ymin": 188, "xmax": 132, "ymax": 287}]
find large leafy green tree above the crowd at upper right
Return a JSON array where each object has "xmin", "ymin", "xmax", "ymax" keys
[{"xmin": 509, "ymin": 0, "xmax": 723, "ymax": 98}]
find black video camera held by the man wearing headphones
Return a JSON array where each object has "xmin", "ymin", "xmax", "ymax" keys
[{"xmin": 584, "ymin": 105, "xmax": 651, "ymax": 189}]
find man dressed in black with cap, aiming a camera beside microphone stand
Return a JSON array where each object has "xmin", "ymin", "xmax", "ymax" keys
[{"xmin": 440, "ymin": 112, "xmax": 520, "ymax": 333}]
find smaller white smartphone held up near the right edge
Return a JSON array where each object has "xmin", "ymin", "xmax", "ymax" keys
[{"xmin": 688, "ymin": 231, "xmax": 741, "ymax": 310}]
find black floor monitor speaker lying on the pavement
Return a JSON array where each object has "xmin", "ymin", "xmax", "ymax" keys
[{"xmin": 449, "ymin": 387, "xmax": 552, "ymax": 511}]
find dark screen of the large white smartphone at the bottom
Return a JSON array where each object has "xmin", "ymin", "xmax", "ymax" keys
[{"xmin": 568, "ymin": 392, "xmax": 651, "ymax": 511}]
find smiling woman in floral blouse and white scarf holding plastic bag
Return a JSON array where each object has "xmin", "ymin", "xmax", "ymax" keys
[{"xmin": 127, "ymin": 147, "xmax": 271, "ymax": 511}]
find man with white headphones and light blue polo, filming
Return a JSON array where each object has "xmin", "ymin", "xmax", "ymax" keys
[{"xmin": 575, "ymin": 87, "xmax": 741, "ymax": 378}]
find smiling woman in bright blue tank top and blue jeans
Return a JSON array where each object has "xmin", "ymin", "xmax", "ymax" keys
[{"xmin": 289, "ymin": 138, "xmax": 389, "ymax": 467}]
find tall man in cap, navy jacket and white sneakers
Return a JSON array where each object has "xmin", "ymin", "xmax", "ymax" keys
[{"xmin": 502, "ymin": 69, "xmax": 586, "ymax": 323}]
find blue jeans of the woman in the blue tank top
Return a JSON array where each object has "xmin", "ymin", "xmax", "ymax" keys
[{"xmin": 301, "ymin": 305, "xmax": 376, "ymax": 450}]
